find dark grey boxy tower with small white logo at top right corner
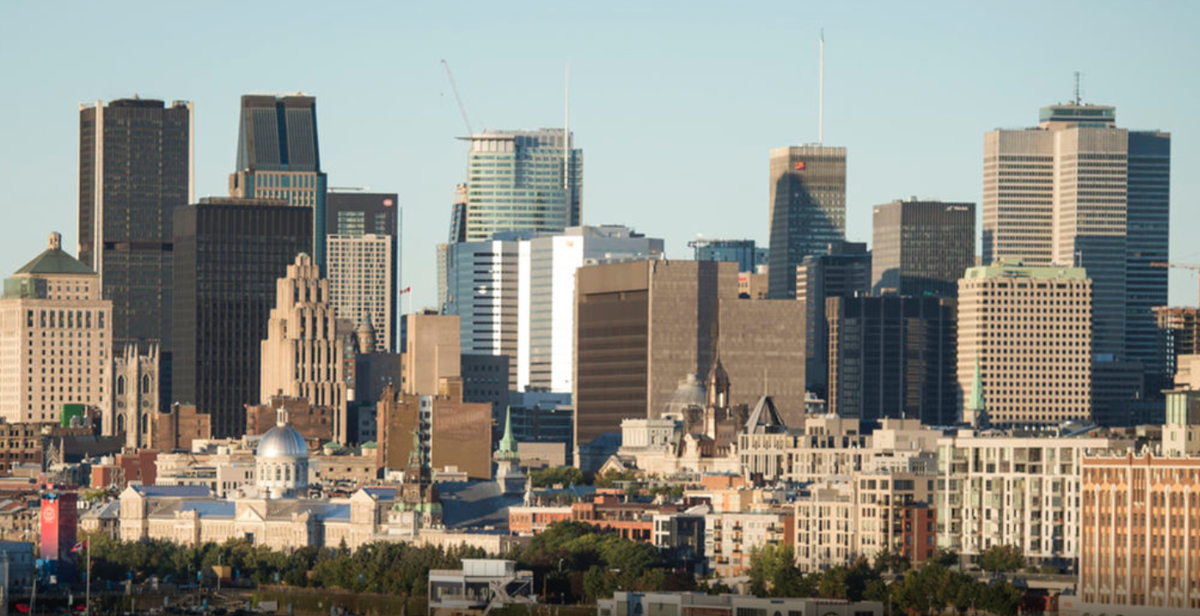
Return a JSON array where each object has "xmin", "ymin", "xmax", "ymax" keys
[{"xmin": 871, "ymin": 198, "xmax": 974, "ymax": 298}]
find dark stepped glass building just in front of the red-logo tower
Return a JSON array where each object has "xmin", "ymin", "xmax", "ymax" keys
[{"xmin": 796, "ymin": 241, "xmax": 871, "ymax": 396}]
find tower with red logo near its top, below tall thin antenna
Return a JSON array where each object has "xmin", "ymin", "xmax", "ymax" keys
[{"xmin": 768, "ymin": 145, "xmax": 846, "ymax": 299}]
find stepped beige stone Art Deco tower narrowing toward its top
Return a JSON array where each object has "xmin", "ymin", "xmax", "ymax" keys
[{"xmin": 262, "ymin": 255, "xmax": 348, "ymax": 442}]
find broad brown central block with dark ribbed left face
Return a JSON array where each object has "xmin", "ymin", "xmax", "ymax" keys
[{"xmin": 575, "ymin": 261, "xmax": 738, "ymax": 447}]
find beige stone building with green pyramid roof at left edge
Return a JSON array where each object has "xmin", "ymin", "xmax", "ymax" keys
[{"xmin": 0, "ymin": 233, "xmax": 112, "ymax": 425}]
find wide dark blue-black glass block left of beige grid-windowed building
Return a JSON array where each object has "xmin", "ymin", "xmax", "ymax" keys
[{"xmin": 826, "ymin": 295, "xmax": 959, "ymax": 425}]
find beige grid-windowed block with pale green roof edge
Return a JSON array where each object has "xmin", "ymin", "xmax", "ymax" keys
[{"xmin": 958, "ymin": 262, "xmax": 1094, "ymax": 424}]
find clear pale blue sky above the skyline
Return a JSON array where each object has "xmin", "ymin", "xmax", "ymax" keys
[{"xmin": 0, "ymin": 0, "xmax": 1200, "ymax": 307}]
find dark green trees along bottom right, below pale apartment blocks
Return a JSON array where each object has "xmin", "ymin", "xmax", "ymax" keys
[{"xmin": 739, "ymin": 545, "xmax": 1022, "ymax": 616}]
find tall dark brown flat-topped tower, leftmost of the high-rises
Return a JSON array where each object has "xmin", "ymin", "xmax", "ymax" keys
[{"xmin": 79, "ymin": 97, "xmax": 192, "ymax": 408}]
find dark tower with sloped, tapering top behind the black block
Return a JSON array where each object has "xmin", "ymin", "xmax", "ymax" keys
[{"xmin": 229, "ymin": 95, "xmax": 328, "ymax": 267}]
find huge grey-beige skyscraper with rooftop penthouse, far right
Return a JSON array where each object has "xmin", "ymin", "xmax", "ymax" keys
[{"xmin": 983, "ymin": 101, "xmax": 1170, "ymax": 365}]
